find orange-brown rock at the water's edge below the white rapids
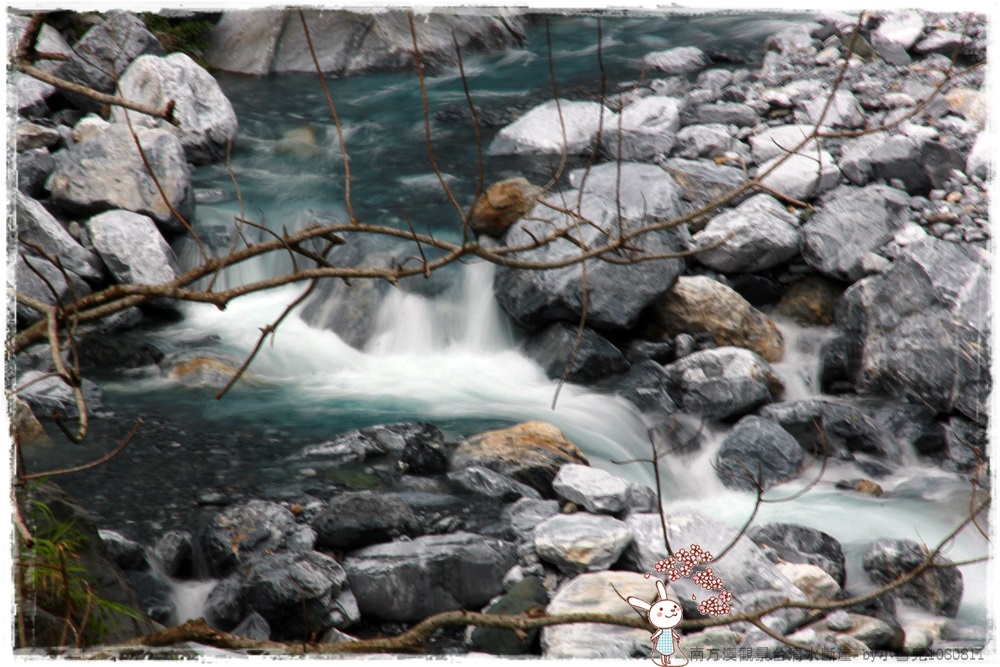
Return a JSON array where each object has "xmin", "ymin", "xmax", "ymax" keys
[{"xmin": 451, "ymin": 421, "xmax": 590, "ymax": 498}]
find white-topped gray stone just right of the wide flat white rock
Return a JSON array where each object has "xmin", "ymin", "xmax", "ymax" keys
[{"xmin": 601, "ymin": 95, "xmax": 680, "ymax": 162}]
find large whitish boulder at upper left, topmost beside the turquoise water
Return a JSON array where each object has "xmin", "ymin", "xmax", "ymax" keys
[{"xmin": 111, "ymin": 53, "xmax": 239, "ymax": 164}]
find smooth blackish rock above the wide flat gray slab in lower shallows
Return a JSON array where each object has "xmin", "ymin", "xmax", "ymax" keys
[{"xmin": 311, "ymin": 491, "xmax": 423, "ymax": 551}]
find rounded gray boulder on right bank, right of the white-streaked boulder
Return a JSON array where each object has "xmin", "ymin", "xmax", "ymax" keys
[{"xmin": 802, "ymin": 185, "xmax": 910, "ymax": 282}]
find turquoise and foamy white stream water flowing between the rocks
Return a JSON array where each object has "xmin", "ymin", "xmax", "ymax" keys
[{"xmin": 19, "ymin": 14, "xmax": 987, "ymax": 636}]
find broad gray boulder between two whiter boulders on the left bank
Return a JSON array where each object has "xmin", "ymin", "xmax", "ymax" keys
[{"xmin": 48, "ymin": 125, "xmax": 194, "ymax": 233}]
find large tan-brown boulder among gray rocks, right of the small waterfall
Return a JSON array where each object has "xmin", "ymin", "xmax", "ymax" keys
[{"xmin": 647, "ymin": 276, "xmax": 785, "ymax": 362}]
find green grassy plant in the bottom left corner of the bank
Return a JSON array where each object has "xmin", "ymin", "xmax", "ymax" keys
[{"xmin": 17, "ymin": 500, "xmax": 141, "ymax": 648}]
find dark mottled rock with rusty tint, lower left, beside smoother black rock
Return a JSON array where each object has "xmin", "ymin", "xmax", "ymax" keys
[{"xmin": 198, "ymin": 499, "xmax": 308, "ymax": 580}]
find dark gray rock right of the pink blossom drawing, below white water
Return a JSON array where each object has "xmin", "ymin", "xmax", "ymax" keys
[{"xmin": 747, "ymin": 523, "xmax": 847, "ymax": 587}]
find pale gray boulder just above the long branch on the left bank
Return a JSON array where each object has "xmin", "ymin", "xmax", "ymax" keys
[{"xmin": 86, "ymin": 211, "xmax": 180, "ymax": 285}]
